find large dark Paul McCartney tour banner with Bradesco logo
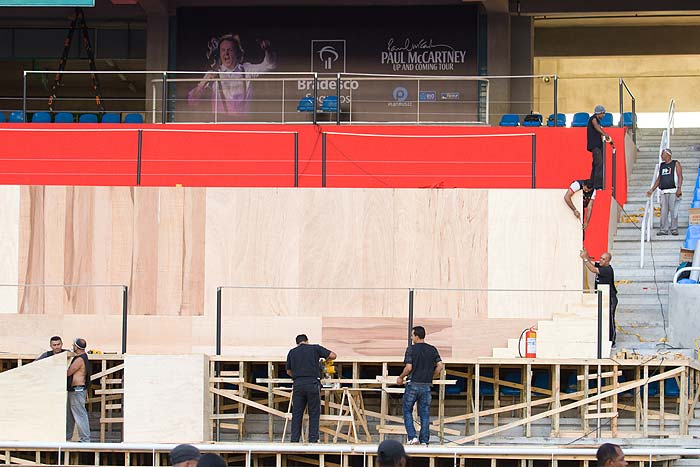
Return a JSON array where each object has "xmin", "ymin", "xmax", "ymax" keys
[{"xmin": 176, "ymin": 4, "xmax": 480, "ymax": 121}]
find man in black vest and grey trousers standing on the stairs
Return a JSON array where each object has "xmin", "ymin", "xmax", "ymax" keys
[{"xmin": 647, "ymin": 148, "xmax": 683, "ymax": 235}]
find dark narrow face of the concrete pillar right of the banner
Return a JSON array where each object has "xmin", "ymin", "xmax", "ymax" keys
[{"xmin": 510, "ymin": 16, "xmax": 532, "ymax": 118}]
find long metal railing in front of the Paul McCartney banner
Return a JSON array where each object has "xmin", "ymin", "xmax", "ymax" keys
[{"xmin": 21, "ymin": 70, "xmax": 560, "ymax": 126}]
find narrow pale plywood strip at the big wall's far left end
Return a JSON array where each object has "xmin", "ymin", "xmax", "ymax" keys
[{"xmin": 0, "ymin": 186, "xmax": 20, "ymax": 314}]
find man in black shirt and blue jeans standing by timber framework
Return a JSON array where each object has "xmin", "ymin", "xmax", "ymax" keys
[{"xmin": 396, "ymin": 326, "xmax": 444, "ymax": 445}]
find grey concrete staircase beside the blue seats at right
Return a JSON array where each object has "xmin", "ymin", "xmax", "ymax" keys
[{"xmin": 611, "ymin": 128, "xmax": 700, "ymax": 353}]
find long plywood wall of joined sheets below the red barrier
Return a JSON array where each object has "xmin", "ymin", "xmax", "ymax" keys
[{"xmin": 0, "ymin": 187, "xmax": 581, "ymax": 358}]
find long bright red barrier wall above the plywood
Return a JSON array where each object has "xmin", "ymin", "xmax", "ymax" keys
[{"xmin": 0, "ymin": 124, "xmax": 627, "ymax": 256}]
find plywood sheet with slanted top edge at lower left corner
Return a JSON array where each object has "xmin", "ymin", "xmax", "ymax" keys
[{"xmin": 0, "ymin": 354, "xmax": 67, "ymax": 442}]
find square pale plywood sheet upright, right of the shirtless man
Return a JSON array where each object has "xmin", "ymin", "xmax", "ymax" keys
[{"xmin": 124, "ymin": 355, "xmax": 209, "ymax": 443}]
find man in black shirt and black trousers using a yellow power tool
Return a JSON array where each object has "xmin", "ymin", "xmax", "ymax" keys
[{"xmin": 287, "ymin": 334, "xmax": 338, "ymax": 443}]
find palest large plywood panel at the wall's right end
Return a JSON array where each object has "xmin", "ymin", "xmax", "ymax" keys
[{"xmin": 488, "ymin": 190, "xmax": 582, "ymax": 319}]
